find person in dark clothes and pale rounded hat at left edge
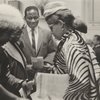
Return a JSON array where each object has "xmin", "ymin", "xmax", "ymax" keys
[{"xmin": 0, "ymin": 4, "xmax": 34, "ymax": 96}]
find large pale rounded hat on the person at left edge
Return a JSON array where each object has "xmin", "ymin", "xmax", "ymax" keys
[{"xmin": 0, "ymin": 4, "xmax": 25, "ymax": 33}]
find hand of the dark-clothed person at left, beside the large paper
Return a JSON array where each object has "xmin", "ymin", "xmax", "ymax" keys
[{"xmin": 22, "ymin": 81, "xmax": 35, "ymax": 96}]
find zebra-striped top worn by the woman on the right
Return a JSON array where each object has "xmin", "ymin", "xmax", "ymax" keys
[{"xmin": 54, "ymin": 32, "xmax": 98, "ymax": 100}]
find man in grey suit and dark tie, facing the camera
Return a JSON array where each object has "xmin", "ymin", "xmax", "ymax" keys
[{"xmin": 20, "ymin": 6, "xmax": 56, "ymax": 79}]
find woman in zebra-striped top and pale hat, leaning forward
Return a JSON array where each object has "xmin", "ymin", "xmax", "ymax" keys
[{"xmin": 44, "ymin": 6, "xmax": 98, "ymax": 100}]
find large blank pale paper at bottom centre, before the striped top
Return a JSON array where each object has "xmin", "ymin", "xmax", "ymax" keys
[{"xmin": 30, "ymin": 73, "xmax": 69, "ymax": 100}]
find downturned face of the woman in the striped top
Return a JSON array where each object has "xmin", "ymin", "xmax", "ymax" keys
[{"xmin": 47, "ymin": 16, "xmax": 64, "ymax": 40}]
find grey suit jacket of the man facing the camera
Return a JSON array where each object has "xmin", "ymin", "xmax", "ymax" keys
[{"xmin": 20, "ymin": 26, "xmax": 56, "ymax": 64}]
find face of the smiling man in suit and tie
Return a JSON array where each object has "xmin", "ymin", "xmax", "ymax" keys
[{"xmin": 25, "ymin": 9, "xmax": 39, "ymax": 29}]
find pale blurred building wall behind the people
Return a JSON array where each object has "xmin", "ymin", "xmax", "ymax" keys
[{"xmin": 0, "ymin": 0, "xmax": 100, "ymax": 38}]
